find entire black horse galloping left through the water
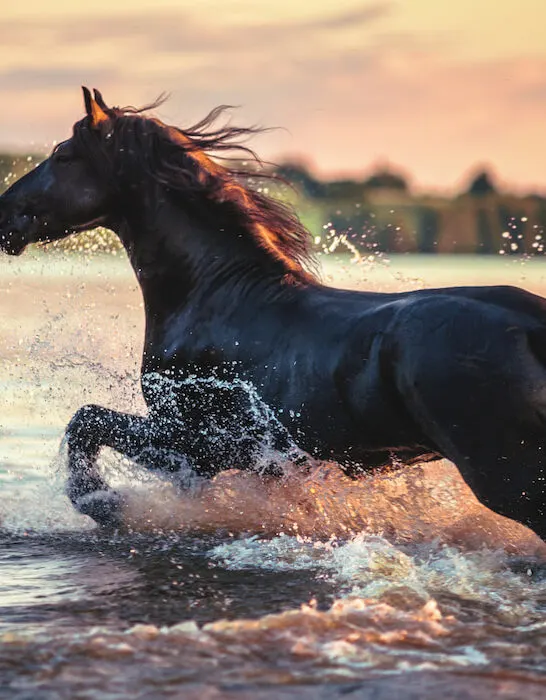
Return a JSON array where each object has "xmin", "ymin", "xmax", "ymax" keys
[{"xmin": 0, "ymin": 88, "xmax": 546, "ymax": 537}]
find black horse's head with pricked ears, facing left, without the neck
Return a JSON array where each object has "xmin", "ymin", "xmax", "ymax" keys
[{"xmin": 0, "ymin": 88, "xmax": 115, "ymax": 255}]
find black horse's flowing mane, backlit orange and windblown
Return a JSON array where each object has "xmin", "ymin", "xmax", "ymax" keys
[{"xmin": 70, "ymin": 98, "xmax": 316, "ymax": 280}]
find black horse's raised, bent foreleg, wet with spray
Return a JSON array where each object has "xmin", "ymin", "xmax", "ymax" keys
[{"xmin": 66, "ymin": 405, "xmax": 152, "ymax": 527}]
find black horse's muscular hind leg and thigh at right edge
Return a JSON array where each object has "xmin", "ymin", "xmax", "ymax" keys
[{"xmin": 398, "ymin": 308, "xmax": 546, "ymax": 538}]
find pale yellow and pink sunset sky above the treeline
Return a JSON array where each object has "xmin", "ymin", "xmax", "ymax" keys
[{"xmin": 0, "ymin": 0, "xmax": 546, "ymax": 193}]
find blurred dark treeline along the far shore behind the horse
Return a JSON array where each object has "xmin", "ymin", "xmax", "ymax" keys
[{"xmin": 0, "ymin": 153, "xmax": 546, "ymax": 255}]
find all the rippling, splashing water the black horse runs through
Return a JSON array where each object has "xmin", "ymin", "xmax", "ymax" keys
[{"xmin": 0, "ymin": 254, "xmax": 546, "ymax": 700}]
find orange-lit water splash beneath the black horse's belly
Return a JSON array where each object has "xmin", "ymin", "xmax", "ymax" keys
[{"xmin": 118, "ymin": 460, "xmax": 546, "ymax": 556}]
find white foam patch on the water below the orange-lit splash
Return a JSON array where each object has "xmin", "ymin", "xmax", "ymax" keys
[{"xmin": 210, "ymin": 533, "xmax": 546, "ymax": 621}]
